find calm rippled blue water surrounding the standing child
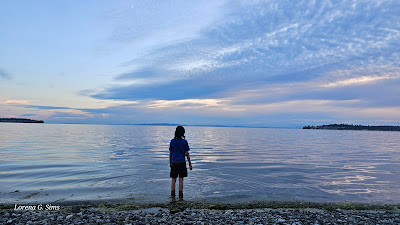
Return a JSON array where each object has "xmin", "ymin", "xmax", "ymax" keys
[{"xmin": 0, "ymin": 123, "xmax": 400, "ymax": 204}]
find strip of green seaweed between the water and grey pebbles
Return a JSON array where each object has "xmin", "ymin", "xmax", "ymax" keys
[{"xmin": 0, "ymin": 199, "xmax": 400, "ymax": 213}]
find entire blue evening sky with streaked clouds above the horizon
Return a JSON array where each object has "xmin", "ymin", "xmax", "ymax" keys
[{"xmin": 0, "ymin": 0, "xmax": 400, "ymax": 127}]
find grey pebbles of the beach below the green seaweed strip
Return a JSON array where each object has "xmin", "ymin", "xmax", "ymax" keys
[{"xmin": 0, "ymin": 207, "xmax": 400, "ymax": 225}]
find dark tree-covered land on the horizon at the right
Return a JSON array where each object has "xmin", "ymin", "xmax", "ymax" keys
[{"xmin": 303, "ymin": 124, "xmax": 400, "ymax": 131}]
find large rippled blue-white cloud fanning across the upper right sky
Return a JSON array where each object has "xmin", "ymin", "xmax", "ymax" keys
[{"xmin": 90, "ymin": 1, "xmax": 400, "ymax": 104}]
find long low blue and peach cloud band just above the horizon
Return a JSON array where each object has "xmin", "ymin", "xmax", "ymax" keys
[{"xmin": 3, "ymin": 92, "xmax": 400, "ymax": 127}]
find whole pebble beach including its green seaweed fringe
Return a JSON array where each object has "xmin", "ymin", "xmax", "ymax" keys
[{"xmin": 0, "ymin": 201, "xmax": 400, "ymax": 225}]
